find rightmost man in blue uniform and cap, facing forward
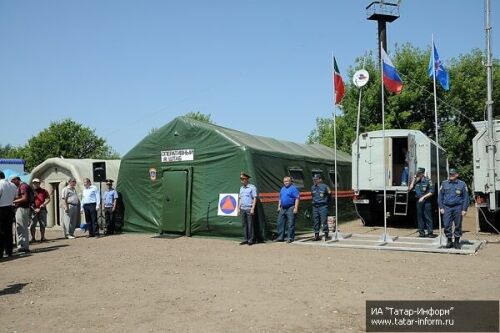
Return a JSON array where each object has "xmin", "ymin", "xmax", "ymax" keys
[{"xmin": 438, "ymin": 169, "xmax": 469, "ymax": 249}]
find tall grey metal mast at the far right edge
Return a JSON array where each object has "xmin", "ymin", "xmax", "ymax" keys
[{"xmin": 485, "ymin": 0, "xmax": 497, "ymax": 211}]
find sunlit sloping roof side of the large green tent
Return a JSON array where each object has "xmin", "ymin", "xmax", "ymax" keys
[{"xmin": 165, "ymin": 117, "xmax": 351, "ymax": 162}]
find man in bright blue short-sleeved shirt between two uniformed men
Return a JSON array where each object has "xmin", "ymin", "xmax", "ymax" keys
[{"xmin": 276, "ymin": 176, "xmax": 300, "ymax": 243}]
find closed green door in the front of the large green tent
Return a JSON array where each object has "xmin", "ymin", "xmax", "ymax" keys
[{"xmin": 161, "ymin": 170, "xmax": 189, "ymax": 233}]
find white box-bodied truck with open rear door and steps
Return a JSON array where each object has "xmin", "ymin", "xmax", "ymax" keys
[{"xmin": 352, "ymin": 129, "xmax": 448, "ymax": 226}]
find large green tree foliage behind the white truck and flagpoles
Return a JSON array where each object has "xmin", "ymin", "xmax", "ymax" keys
[{"xmin": 307, "ymin": 44, "xmax": 500, "ymax": 182}]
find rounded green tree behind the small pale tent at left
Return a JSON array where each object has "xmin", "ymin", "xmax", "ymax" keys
[{"xmin": 21, "ymin": 119, "xmax": 120, "ymax": 170}]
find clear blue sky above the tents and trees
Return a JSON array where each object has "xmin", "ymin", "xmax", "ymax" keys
[{"xmin": 0, "ymin": 0, "xmax": 500, "ymax": 155}]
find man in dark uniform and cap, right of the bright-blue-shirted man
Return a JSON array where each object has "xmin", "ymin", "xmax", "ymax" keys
[{"xmin": 311, "ymin": 174, "xmax": 330, "ymax": 241}]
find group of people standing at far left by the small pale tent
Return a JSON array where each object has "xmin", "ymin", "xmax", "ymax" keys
[{"xmin": 0, "ymin": 171, "xmax": 118, "ymax": 258}]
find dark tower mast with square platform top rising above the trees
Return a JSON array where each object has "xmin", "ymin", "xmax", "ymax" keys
[{"xmin": 366, "ymin": 0, "xmax": 401, "ymax": 62}]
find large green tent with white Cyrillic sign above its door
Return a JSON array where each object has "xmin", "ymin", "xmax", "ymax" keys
[{"xmin": 117, "ymin": 117, "xmax": 353, "ymax": 239}]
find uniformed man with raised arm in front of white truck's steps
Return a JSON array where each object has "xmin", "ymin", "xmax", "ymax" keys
[{"xmin": 410, "ymin": 168, "xmax": 435, "ymax": 238}]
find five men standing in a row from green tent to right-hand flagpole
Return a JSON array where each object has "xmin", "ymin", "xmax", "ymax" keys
[{"xmin": 238, "ymin": 168, "xmax": 469, "ymax": 249}]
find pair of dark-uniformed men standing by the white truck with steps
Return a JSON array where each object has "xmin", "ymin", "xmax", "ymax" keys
[{"xmin": 409, "ymin": 168, "xmax": 469, "ymax": 249}]
